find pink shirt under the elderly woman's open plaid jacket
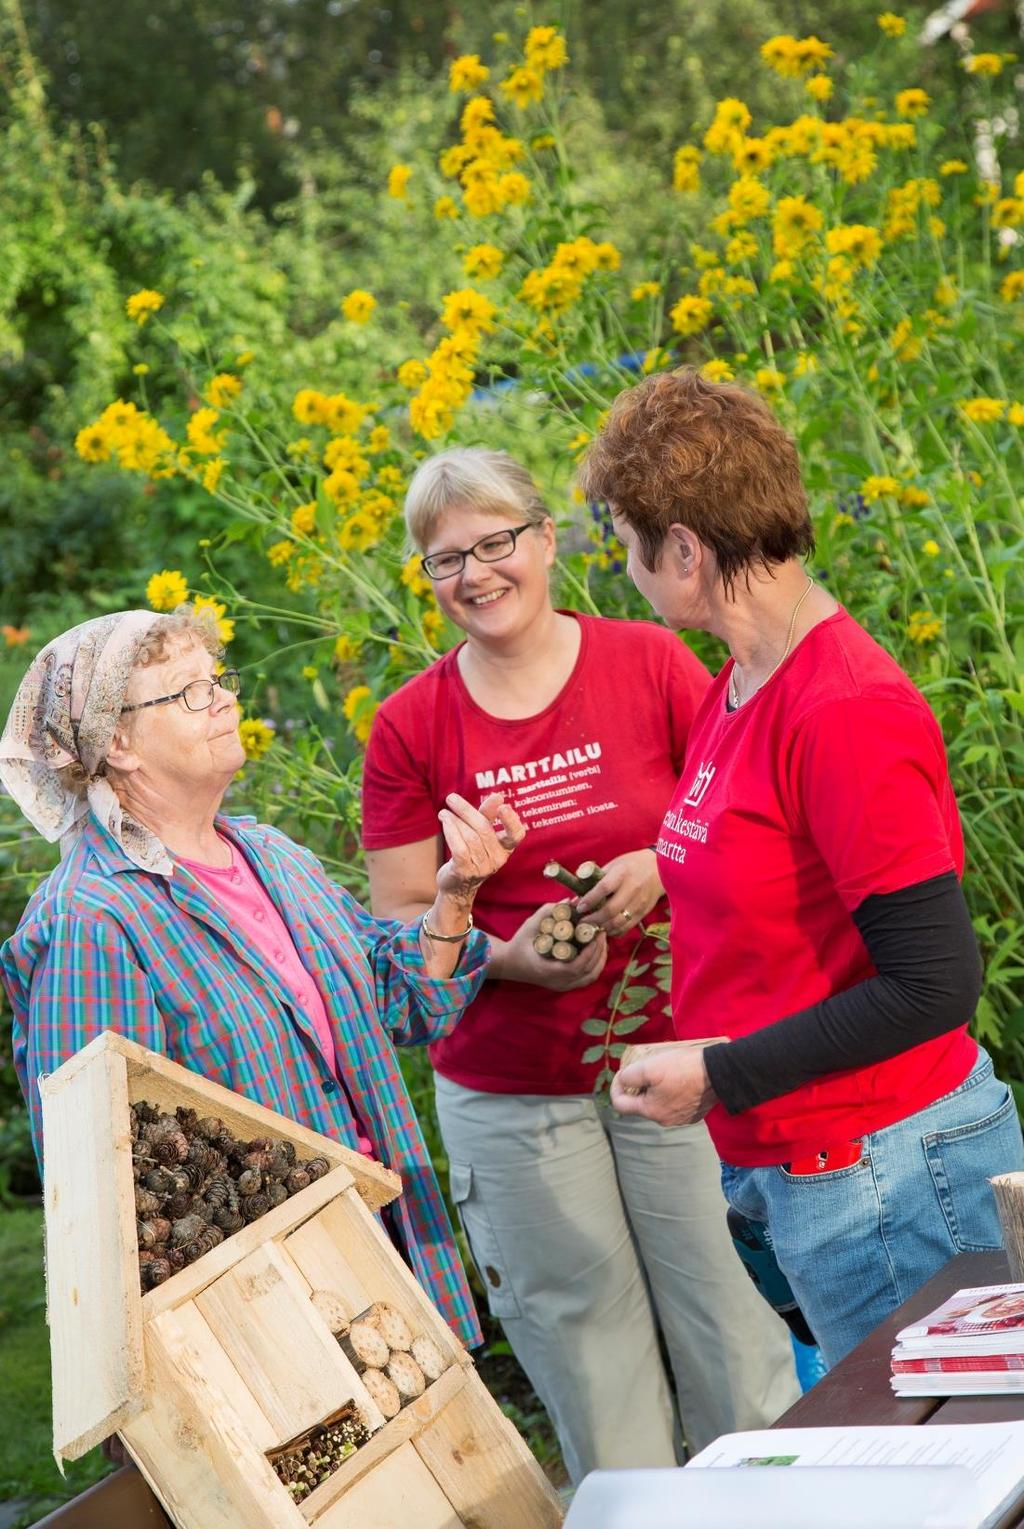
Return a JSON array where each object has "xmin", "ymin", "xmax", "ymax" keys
[{"xmin": 179, "ymin": 838, "xmax": 373, "ymax": 1157}]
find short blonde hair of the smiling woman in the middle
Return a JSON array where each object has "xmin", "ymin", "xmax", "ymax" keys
[{"xmin": 405, "ymin": 446, "xmax": 550, "ymax": 550}]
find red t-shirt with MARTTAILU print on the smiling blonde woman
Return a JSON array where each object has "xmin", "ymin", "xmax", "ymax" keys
[{"xmin": 362, "ymin": 615, "xmax": 709, "ymax": 1095}]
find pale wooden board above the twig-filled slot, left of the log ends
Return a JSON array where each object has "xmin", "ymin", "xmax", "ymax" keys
[{"xmin": 196, "ymin": 1243, "xmax": 384, "ymax": 1443}]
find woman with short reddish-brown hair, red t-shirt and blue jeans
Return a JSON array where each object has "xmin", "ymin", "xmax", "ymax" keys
[{"xmin": 581, "ymin": 370, "xmax": 1024, "ymax": 1364}]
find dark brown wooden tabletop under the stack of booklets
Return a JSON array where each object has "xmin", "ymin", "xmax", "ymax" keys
[{"xmin": 773, "ymin": 1252, "xmax": 1024, "ymax": 1529}]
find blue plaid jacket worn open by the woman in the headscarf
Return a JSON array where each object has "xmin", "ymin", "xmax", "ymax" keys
[{"xmin": 0, "ymin": 818, "xmax": 488, "ymax": 1344}]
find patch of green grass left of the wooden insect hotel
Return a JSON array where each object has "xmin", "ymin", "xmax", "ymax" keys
[{"xmin": 0, "ymin": 1206, "xmax": 110, "ymax": 1529}]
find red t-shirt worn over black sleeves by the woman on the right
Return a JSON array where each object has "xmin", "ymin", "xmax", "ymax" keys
[{"xmin": 659, "ymin": 610, "xmax": 977, "ymax": 1167}]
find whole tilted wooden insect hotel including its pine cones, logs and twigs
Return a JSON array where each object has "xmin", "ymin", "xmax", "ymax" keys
[{"xmin": 41, "ymin": 1032, "xmax": 562, "ymax": 1529}]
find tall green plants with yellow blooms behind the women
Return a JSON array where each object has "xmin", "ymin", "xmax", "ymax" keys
[{"xmin": 78, "ymin": 23, "xmax": 1024, "ymax": 1072}]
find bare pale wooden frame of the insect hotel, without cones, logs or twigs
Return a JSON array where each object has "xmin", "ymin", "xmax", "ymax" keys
[{"xmin": 41, "ymin": 1032, "xmax": 562, "ymax": 1529}]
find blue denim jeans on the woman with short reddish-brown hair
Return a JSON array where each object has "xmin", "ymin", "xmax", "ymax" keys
[{"xmin": 721, "ymin": 1050, "xmax": 1024, "ymax": 1364}]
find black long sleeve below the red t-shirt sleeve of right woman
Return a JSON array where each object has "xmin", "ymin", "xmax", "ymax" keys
[{"xmin": 705, "ymin": 872, "xmax": 981, "ymax": 1115}]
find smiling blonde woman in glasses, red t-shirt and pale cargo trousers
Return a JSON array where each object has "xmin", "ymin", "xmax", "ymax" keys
[{"xmin": 364, "ymin": 450, "xmax": 796, "ymax": 1480}]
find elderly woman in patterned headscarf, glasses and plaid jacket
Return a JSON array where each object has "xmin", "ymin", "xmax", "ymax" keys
[{"xmin": 0, "ymin": 610, "xmax": 523, "ymax": 1344}]
